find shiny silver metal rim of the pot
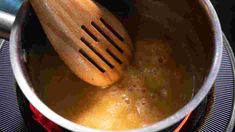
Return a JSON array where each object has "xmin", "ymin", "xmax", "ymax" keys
[{"xmin": 10, "ymin": 0, "xmax": 223, "ymax": 132}]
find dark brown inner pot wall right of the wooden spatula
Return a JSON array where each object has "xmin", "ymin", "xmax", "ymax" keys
[{"xmin": 96, "ymin": 0, "xmax": 214, "ymax": 92}]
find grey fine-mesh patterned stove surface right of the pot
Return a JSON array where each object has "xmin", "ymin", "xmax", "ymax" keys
[{"xmin": 198, "ymin": 36, "xmax": 235, "ymax": 132}]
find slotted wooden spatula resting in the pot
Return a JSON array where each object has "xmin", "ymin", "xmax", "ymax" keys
[{"xmin": 30, "ymin": 0, "xmax": 132, "ymax": 88}]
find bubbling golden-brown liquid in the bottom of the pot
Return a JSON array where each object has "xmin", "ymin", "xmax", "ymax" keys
[{"xmin": 29, "ymin": 40, "xmax": 192, "ymax": 130}]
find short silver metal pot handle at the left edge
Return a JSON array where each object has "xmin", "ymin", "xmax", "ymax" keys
[{"xmin": 0, "ymin": 11, "xmax": 15, "ymax": 39}]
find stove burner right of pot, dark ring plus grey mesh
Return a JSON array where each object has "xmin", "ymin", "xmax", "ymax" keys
[{"xmin": 182, "ymin": 36, "xmax": 235, "ymax": 132}]
